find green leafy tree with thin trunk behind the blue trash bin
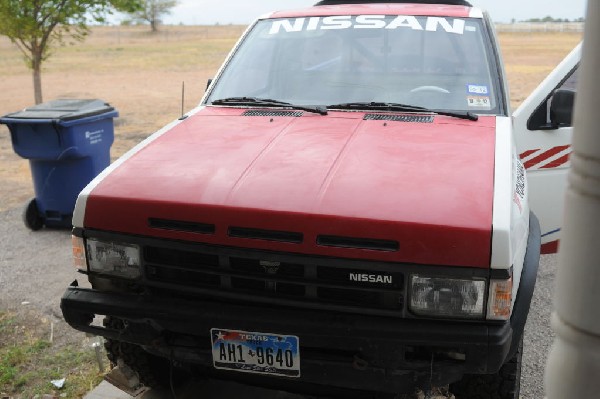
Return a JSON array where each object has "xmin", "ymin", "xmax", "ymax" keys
[{"xmin": 0, "ymin": 0, "xmax": 140, "ymax": 104}]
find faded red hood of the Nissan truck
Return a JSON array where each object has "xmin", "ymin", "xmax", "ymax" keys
[{"xmin": 84, "ymin": 107, "xmax": 495, "ymax": 267}]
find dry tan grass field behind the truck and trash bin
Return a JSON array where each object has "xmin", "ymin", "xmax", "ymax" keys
[{"xmin": 0, "ymin": 26, "xmax": 581, "ymax": 211}]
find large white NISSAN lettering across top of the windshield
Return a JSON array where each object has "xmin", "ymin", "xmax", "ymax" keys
[{"xmin": 269, "ymin": 15, "xmax": 470, "ymax": 35}]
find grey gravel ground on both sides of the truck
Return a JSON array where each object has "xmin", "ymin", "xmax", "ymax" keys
[{"xmin": 0, "ymin": 209, "xmax": 557, "ymax": 399}]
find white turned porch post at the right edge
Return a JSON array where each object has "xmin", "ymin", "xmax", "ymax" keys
[{"xmin": 545, "ymin": 0, "xmax": 600, "ymax": 399}]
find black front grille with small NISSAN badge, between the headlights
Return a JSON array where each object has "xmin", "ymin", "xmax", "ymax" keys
[{"xmin": 143, "ymin": 245, "xmax": 405, "ymax": 316}]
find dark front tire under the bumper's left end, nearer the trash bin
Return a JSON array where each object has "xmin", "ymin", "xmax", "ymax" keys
[{"xmin": 103, "ymin": 317, "xmax": 184, "ymax": 389}]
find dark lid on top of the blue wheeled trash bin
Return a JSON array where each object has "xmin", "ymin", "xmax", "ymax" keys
[{"xmin": 4, "ymin": 99, "xmax": 115, "ymax": 121}]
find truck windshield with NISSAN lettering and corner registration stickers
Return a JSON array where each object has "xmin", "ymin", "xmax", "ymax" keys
[{"xmin": 206, "ymin": 15, "xmax": 501, "ymax": 114}]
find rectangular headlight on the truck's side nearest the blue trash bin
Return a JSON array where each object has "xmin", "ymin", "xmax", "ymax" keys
[{"xmin": 86, "ymin": 239, "xmax": 141, "ymax": 279}]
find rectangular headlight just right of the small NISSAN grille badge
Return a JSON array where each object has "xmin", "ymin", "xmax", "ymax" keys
[{"xmin": 410, "ymin": 275, "xmax": 486, "ymax": 319}]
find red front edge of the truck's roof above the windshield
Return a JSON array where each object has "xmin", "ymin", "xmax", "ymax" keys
[{"xmin": 269, "ymin": 3, "xmax": 471, "ymax": 18}]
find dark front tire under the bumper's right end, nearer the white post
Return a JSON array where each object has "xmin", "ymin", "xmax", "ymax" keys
[{"xmin": 450, "ymin": 337, "xmax": 523, "ymax": 399}]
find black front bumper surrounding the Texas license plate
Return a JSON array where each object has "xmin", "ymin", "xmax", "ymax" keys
[{"xmin": 61, "ymin": 286, "xmax": 513, "ymax": 392}]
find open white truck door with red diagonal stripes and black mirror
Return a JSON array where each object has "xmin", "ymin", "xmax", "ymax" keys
[{"xmin": 513, "ymin": 44, "xmax": 581, "ymax": 254}]
